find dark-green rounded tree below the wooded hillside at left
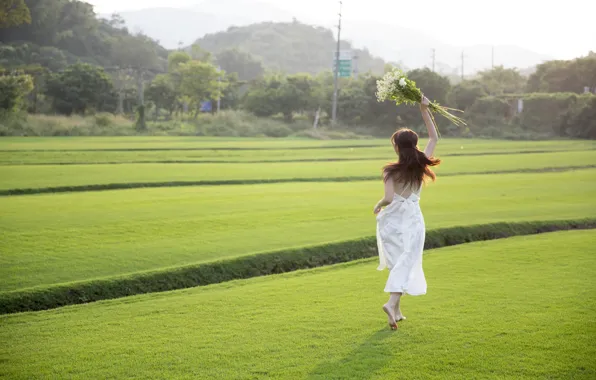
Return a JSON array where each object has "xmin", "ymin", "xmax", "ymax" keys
[{"xmin": 47, "ymin": 63, "xmax": 113, "ymax": 115}]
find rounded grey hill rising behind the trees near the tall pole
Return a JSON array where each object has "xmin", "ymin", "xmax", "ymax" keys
[{"xmin": 195, "ymin": 21, "xmax": 385, "ymax": 74}]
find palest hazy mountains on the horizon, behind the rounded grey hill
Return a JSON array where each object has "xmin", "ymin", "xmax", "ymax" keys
[{"xmin": 113, "ymin": 0, "xmax": 551, "ymax": 76}]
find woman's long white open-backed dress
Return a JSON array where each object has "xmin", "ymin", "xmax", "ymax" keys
[{"xmin": 377, "ymin": 187, "xmax": 426, "ymax": 296}]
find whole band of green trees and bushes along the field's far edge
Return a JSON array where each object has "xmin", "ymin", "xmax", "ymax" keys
[{"xmin": 0, "ymin": 0, "xmax": 596, "ymax": 138}]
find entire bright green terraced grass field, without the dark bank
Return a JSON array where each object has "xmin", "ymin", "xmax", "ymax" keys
[{"xmin": 0, "ymin": 137, "xmax": 596, "ymax": 379}]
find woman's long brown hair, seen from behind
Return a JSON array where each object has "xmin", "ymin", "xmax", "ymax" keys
[{"xmin": 383, "ymin": 128, "xmax": 441, "ymax": 188}]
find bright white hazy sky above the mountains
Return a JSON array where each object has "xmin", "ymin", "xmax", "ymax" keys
[{"xmin": 87, "ymin": 0, "xmax": 596, "ymax": 59}]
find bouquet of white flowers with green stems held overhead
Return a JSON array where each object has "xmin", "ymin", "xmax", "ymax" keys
[{"xmin": 377, "ymin": 69, "xmax": 466, "ymax": 133}]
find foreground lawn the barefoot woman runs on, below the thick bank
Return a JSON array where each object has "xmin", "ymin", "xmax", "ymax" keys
[{"xmin": 0, "ymin": 231, "xmax": 596, "ymax": 379}]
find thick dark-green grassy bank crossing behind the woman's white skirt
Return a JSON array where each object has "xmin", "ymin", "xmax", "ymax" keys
[{"xmin": 0, "ymin": 218, "xmax": 596, "ymax": 314}]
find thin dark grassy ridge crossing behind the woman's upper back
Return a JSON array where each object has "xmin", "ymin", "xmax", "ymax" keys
[{"xmin": 0, "ymin": 165, "xmax": 596, "ymax": 196}]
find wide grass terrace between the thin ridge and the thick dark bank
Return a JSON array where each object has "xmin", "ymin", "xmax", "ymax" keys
[{"xmin": 0, "ymin": 170, "xmax": 596, "ymax": 291}]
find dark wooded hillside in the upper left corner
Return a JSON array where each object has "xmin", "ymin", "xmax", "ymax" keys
[{"xmin": 0, "ymin": 0, "xmax": 168, "ymax": 71}]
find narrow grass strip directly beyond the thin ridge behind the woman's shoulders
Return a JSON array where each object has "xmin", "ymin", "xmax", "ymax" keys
[{"xmin": 0, "ymin": 150, "xmax": 596, "ymax": 191}]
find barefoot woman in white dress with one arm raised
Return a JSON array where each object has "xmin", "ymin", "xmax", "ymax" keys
[{"xmin": 374, "ymin": 96, "xmax": 441, "ymax": 330}]
